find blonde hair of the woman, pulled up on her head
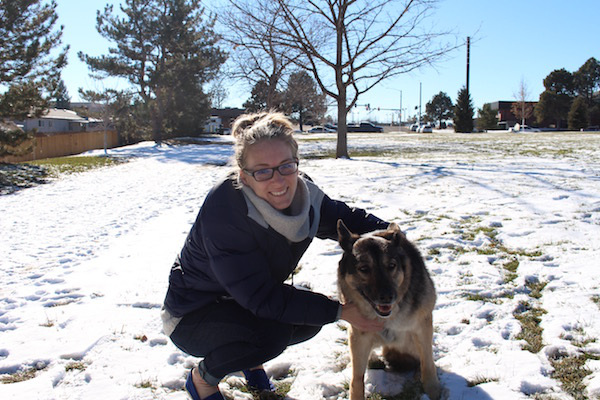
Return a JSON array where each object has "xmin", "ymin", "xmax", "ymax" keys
[{"xmin": 231, "ymin": 111, "xmax": 298, "ymax": 169}]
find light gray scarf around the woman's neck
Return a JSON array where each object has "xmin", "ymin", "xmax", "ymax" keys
[{"xmin": 239, "ymin": 176, "xmax": 325, "ymax": 243}]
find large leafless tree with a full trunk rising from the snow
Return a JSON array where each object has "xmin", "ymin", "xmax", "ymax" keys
[{"xmin": 268, "ymin": 0, "xmax": 456, "ymax": 157}]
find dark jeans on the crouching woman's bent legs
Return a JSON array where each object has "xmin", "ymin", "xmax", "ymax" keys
[{"xmin": 171, "ymin": 300, "xmax": 321, "ymax": 386}]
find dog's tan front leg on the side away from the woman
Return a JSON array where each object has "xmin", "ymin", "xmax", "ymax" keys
[{"xmin": 412, "ymin": 316, "xmax": 441, "ymax": 400}]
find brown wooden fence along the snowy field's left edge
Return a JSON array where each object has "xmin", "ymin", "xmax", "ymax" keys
[{"xmin": 0, "ymin": 131, "xmax": 119, "ymax": 163}]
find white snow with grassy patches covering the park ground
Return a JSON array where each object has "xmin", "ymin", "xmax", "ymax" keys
[{"xmin": 0, "ymin": 133, "xmax": 600, "ymax": 400}]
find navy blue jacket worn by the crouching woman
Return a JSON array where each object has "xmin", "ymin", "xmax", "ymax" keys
[{"xmin": 165, "ymin": 177, "xmax": 388, "ymax": 326}]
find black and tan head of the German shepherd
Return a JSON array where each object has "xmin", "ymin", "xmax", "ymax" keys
[{"xmin": 337, "ymin": 220, "xmax": 410, "ymax": 317}]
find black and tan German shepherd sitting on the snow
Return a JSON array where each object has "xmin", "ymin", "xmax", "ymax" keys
[{"xmin": 337, "ymin": 220, "xmax": 441, "ymax": 400}]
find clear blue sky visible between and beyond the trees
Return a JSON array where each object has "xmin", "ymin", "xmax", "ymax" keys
[{"xmin": 58, "ymin": 0, "xmax": 600, "ymax": 122}]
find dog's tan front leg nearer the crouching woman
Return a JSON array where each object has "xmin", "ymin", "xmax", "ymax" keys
[{"xmin": 350, "ymin": 327, "xmax": 374, "ymax": 400}]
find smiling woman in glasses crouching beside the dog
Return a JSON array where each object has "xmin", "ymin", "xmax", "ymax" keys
[{"xmin": 162, "ymin": 112, "xmax": 388, "ymax": 400}]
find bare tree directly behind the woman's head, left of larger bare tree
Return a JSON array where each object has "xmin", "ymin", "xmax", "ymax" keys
[{"xmin": 219, "ymin": 0, "xmax": 297, "ymax": 108}]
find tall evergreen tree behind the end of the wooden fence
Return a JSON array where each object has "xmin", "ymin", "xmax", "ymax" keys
[{"xmin": 79, "ymin": 0, "xmax": 226, "ymax": 142}]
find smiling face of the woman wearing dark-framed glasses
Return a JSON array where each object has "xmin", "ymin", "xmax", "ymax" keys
[{"xmin": 240, "ymin": 139, "xmax": 298, "ymax": 210}]
